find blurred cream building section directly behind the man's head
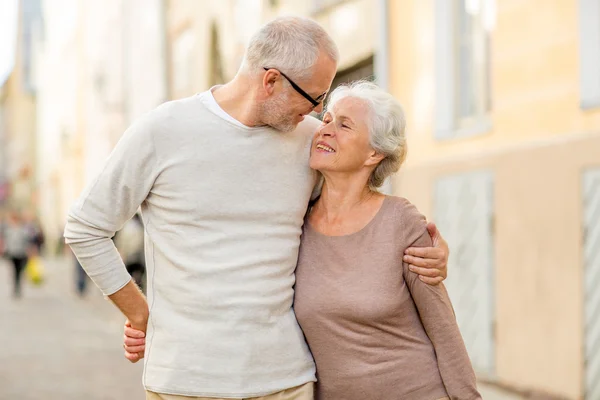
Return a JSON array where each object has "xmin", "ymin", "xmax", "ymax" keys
[{"xmin": 166, "ymin": 0, "xmax": 386, "ymax": 98}]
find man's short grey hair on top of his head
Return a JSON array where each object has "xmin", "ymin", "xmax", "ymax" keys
[{"xmin": 242, "ymin": 17, "xmax": 339, "ymax": 79}]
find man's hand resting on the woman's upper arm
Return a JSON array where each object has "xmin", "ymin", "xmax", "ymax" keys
[{"xmin": 403, "ymin": 222, "xmax": 450, "ymax": 285}]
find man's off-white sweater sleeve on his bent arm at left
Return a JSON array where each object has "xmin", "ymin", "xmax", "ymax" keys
[{"xmin": 64, "ymin": 113, "xmax": 158, "ymax": 295}]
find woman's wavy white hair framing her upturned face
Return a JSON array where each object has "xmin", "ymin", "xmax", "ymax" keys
[{"xmin": 327, "ymin": 80, "xmax": 406, "ymax": 190}]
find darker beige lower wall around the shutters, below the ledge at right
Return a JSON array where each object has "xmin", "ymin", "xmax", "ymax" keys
[{"xmin": 394, "ymin": 135, "xmax": 600, "ymax": 399}]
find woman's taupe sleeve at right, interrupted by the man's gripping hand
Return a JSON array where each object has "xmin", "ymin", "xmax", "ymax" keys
[{"xmin": 401, "ymin": 205, "xmax": 481, "ymax": 400}]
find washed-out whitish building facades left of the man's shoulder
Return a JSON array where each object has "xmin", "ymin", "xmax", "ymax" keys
[{"xmin": 0, "ymin": 0, "xmax": 167, "ymax": 248}]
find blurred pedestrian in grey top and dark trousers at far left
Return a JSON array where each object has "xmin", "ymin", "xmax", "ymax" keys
[{"xmin": 4, "ymin": 211, "xmax": 30, "ymax": 298}]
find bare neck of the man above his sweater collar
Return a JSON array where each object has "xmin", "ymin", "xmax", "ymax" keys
[{"xmin": 212, "ymin": 75, "xmax": 264, "ymax": 127}]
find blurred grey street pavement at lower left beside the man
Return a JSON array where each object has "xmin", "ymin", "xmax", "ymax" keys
[{"xmin": 0, "ymin": 258, "xmax": 144, "ymax": 400}]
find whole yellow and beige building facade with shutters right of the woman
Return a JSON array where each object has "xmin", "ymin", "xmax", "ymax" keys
[{"xmin": 389, "ymin": 0, "xmax": 600, "ymax": 399}]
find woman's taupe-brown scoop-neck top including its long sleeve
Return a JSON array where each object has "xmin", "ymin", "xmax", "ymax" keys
[{"xmin": 294, "ymin": 197, "xmax": 481, "ymax": 400}]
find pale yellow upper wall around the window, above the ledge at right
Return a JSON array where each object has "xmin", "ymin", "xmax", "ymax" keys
[{"xmin": 389, "ymin": 0, "xmax": 600, "ymax": 163}]
